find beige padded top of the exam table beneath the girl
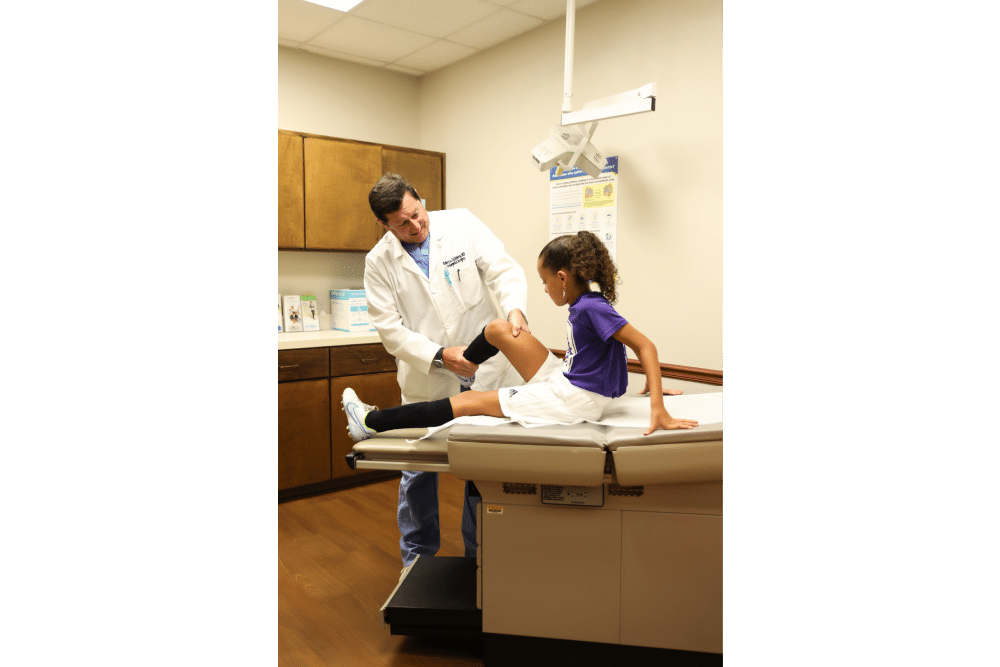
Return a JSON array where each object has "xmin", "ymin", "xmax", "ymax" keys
[{"xmin": 352, "ymin": 392, "xmax": 723, "ymax": 486}]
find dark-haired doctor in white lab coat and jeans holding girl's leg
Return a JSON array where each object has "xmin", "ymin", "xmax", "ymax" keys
[{"xmin": 365, "ymin": 173, "xmax": 529, "ymax": 567}]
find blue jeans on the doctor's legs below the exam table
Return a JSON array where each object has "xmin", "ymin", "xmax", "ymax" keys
[{"xmin": 396, "ymin": 470, "xmax": 479, "ymax": 565}]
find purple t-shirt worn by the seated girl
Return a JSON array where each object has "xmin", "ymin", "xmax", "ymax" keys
[{"xmin": 563, "ymin": 292, "xmax": 628, "ymax": 398}]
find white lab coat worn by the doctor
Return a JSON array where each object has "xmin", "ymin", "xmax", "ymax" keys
[{"xmin": 365, "ymin": 209, "xmax": 528, "ymax": 403}]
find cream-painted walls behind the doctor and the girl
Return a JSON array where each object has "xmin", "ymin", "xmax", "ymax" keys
[{"xmin": 278, "ymin": 0, "xmax": 723, "ymax": 374}]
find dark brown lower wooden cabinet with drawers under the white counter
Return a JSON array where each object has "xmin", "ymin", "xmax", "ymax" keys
[{"xmin": 278, "ymin": 344, "xmax": 400, "ymax": 501}]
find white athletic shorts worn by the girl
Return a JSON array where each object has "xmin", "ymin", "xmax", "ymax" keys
[{"xmin": 498, "ymin": 352, "xmax": 611, "ymax": 424}]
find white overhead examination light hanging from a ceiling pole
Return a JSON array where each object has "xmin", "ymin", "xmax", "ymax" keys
[{"xmin": 531, "ymin": 0, "xmax": 656, "ymax": 177}]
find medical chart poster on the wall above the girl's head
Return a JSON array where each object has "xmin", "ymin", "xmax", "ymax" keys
[{"xmin": 549, "ymin": 155, "xmax": 618, "ymax": 262}]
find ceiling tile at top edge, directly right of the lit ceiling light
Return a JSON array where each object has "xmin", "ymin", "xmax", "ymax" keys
[{"xmin": 351, "ymin": 0, "xmax": 499, "ymax": 37}]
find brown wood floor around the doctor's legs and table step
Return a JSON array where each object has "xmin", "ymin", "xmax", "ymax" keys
[{"xmin": 278, "ymin": 474, "xmax": 483, "ymax": 667}]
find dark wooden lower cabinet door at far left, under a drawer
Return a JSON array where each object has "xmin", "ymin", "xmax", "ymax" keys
[{"xmin": 278, "ymin": 378, "xmax": 332, "ymax": 491}]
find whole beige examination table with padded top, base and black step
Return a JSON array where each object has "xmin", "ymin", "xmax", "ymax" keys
[{"xmin": 348, "ymin": 392, "xmax": 722, "ymax": 664}]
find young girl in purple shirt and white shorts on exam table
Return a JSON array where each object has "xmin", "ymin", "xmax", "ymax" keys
[{"xmin": 342, "ymin": 232, "xmax": 698, "ymax": 442}]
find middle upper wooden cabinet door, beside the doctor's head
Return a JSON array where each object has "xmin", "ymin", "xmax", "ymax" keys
[{"xmin": 304, "ymin": 137, "xmax": 385, "ymax": 250}]
